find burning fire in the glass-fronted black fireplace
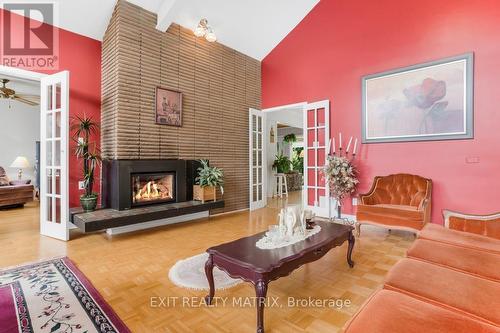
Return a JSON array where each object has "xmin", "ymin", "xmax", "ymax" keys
[{"xmin": 131, "ymin": 172, "xmax": 175, "ymax": 206}]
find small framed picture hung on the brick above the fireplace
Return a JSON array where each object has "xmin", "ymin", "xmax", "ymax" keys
[{"xmin": 155, "ymin": 87, "xmax": 182, "ymax": 127}]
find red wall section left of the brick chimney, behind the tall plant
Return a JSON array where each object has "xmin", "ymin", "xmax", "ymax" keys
[{"xmin": 0, "ymin": 9, "xmax": 101, "ymax": 207}]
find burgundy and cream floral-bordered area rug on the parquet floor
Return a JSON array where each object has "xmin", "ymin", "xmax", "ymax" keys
[{"xmin": 0, "ymin": 258, "xmax": 130, "ymax": 333}]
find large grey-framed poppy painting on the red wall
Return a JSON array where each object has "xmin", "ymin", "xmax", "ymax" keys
[{"xmin": 361, "ymin": 53, "xmax": 474, "ymax": 143}]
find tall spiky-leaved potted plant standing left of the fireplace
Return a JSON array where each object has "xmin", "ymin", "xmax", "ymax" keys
[{"xmin": 71, "ymin": 115, "xmax": 101, "ymax": 212}]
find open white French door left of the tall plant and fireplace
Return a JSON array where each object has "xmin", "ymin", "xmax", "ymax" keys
[{"xmin": 40, "ymin": 71, "xmax": 69, "ymax": 241}]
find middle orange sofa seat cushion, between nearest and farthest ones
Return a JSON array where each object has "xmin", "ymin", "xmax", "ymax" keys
[{"xmin": 384, "ymin": 258, "xmax": 500, "ymax": 326}]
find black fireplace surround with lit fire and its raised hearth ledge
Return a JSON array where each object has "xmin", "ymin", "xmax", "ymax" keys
[{"xmin": 70, "ymin": 160, "xmax": 224, "ymax": 235}]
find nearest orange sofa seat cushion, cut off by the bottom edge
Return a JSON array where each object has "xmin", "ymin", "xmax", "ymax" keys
[{"xmin": 344, "ymin": 290, "xmax": 500, "ymax": 333}]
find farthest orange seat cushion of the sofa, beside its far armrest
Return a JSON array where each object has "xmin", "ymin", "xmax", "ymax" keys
[{"xmin": 418, "ymin": 223, "xmax": 500, "ymax": 254}]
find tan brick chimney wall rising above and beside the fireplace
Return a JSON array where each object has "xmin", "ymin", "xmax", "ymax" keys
[{"xmin": 101, "ymin": 0, "xmax": 261, "ymax": 213}]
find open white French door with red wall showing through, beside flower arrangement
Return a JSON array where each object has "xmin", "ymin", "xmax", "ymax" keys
[{"xmin": 302, "ymin": 100, "xmax": 331, "ymax": 217}]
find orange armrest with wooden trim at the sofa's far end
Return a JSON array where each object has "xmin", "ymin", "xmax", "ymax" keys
[{"xmin": 443, "ymin": 209, "xmax": 500, "ymax": 239}]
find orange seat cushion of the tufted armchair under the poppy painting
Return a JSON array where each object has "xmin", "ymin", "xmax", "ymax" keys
[{"xmin": 356, "ymin": 204, "xmax": 424, "ymax": 230}]
